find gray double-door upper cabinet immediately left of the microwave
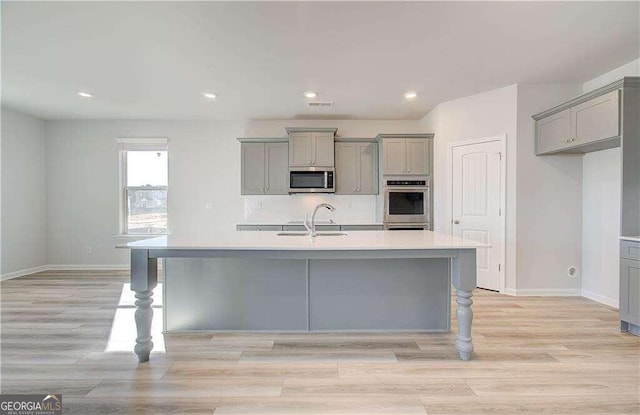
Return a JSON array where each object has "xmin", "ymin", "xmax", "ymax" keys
[{"xmin": 240, "ymin": 142, "xmax": 289, "ymax": 195}]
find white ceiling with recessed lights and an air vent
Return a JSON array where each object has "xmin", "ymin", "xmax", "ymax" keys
[{"xmin": 2, "ymin": 1, "xmax": 640, "ymax": 120}]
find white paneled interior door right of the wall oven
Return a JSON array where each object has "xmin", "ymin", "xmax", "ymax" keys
[{"xmin": 451, "ymin": 141, "xmax": 503, "ymax": 291}]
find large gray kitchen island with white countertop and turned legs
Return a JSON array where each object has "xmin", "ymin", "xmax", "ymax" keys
[{"xmin": 120, "ymin": 231, "xmax": 486, "ymax": 362}]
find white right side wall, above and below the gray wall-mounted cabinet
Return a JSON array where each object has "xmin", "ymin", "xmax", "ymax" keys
[{"xmin": 582, "ymin": 59, "xmax": 640, "ymax": 307}]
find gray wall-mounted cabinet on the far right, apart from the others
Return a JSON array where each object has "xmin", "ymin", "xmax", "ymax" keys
[{"xmin": 533, "ymin": 87, "xmax": 621, "ymax": 155}]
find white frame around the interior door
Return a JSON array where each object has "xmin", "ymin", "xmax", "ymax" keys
[{"xmin": 447, "ymin": 134, "xmax": 507, "ymax": 293}]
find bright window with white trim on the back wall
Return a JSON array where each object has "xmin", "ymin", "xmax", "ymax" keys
[{"xmin": 119, "ymin": 139, "xmax": 169, "ymax": 235}]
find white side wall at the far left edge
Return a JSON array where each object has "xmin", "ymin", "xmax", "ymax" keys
[{"xmin": 1, "ymin": 108, "xmax": 47, "ymax": 279}]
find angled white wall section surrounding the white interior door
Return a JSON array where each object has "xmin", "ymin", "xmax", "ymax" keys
[{"xmin": 421, "ymin": 85, "xmax": 517, "ymax": 289}]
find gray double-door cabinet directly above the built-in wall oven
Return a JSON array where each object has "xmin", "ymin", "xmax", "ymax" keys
[{"xmin": 382, "ymin": 136, "xmax": 433, "ymax": 175}]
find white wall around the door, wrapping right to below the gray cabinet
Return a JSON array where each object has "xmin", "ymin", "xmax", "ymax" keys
[{"xmin": 422, "ymin": 84, "xmax": 582, "ymax": 295}]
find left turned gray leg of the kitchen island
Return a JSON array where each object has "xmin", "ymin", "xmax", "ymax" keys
[{"xmin": 131, "ymin": 249, "xmax": 158, "ymax": 363}]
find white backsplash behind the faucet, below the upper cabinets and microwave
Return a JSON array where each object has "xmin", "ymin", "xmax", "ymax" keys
[{"xmin": 242, "ymin": 194, "xmax": 382, "ymax": 224}]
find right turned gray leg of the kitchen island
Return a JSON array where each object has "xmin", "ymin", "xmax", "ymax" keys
[{"xmin": 451, "ymin": 249, "xmax": 476, "ymax": 360}]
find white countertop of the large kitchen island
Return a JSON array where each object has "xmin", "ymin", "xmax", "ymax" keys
[{"xmin": 118, "ymin": 230, "xmax": 490, "ymax": 251}]
